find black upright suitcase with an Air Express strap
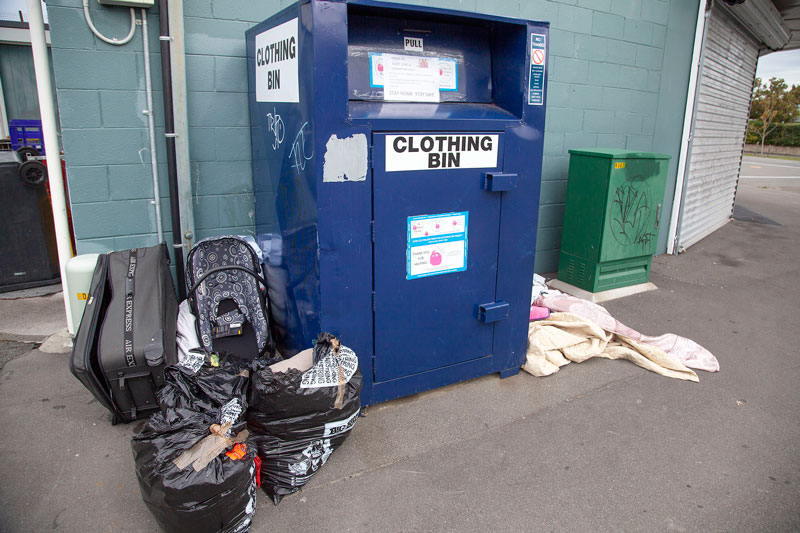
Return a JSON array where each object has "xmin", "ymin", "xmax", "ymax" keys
[{"xmin": 70, "ymin": 244, "xmax": 178, "ymax": 423}]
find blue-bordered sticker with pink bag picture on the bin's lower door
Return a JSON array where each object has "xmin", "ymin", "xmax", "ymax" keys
[{"xmin": 406, "ymin": 211, "xmax": 469, "ymax": 280}]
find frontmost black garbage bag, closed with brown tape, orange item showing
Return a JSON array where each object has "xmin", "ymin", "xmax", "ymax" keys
[{"xmin": 131, "ymin": 408, "xmax": 260, "ymax": 533}]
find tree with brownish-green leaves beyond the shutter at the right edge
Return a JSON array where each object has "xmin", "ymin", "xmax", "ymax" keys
[{"xmin": 747, "ymin": 78, "xmax": 800, "ymax": 154}]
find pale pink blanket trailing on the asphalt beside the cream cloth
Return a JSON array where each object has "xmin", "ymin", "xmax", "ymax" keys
[{"xmin": 533, "ymin": 291, "xmax": 719, "ymax": 372}]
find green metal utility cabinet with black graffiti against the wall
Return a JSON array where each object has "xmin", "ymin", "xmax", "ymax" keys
[{"xmin": 558, "ymin": 148, "xmax": 671, "ymax": 292}]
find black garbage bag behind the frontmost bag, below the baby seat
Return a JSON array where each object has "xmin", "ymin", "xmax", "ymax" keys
[{"xmin": 157, "ymin": 350, "xmax": 250, "ymax": 414}]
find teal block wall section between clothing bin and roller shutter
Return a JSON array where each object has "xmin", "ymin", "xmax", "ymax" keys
[{"xmin": 386, "ymin": 0, "xmax": 680, "ymax": 272}]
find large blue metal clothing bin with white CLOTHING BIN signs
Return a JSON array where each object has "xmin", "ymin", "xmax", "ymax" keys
[{"xmin": 246, "ymin": 0, "xmax": 549, "ymax": 405}]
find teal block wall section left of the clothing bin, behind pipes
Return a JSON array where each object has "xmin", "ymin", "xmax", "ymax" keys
[{"xmin": 47, "ymin": 0, "xmax": 290, "ymax": 253}]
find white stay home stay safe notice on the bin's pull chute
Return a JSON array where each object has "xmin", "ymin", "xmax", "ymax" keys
[{"xmin": 383, "ymin": 54, "xmax": 439, "ymax": 102}]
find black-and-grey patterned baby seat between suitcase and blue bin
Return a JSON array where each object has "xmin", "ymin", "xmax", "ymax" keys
[{"xmin": 186, "ymin": 236, "xmax": 272, "ymax": 358}]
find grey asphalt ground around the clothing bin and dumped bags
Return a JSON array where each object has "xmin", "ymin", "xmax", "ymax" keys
[{"xmin": 0, "ymin": 157, "xmax": 800, "ymax": 532}]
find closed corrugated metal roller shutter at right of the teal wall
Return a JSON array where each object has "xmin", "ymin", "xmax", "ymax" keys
[{"xmin": 677, "ymin": 5, "xmax": 758, "ymax": 250}]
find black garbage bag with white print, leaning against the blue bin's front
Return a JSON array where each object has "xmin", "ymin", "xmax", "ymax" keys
[{"xmin": 247, "ymin": 333, "xmax": 362, "ymax": 505}]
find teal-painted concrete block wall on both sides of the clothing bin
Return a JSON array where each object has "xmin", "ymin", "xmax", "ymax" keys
[{"xmin": 47, "ymin": 0, "xmax": 698, "ymax": 272}]
